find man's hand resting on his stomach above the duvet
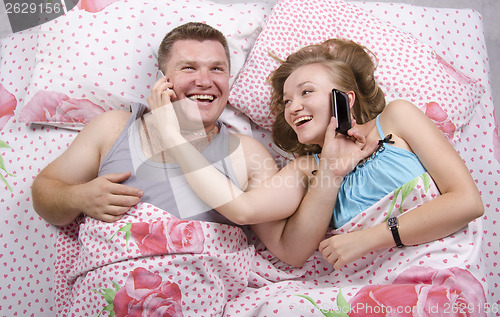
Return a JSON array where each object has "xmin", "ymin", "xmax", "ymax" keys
[{"xmin": 73, "ymin": 172, "xmax": 144, "ymax": 222}]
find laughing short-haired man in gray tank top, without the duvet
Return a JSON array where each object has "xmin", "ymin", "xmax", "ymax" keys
[{"xmin": 32, "ymin": 23, "xmax": 369, "ymax": 266}]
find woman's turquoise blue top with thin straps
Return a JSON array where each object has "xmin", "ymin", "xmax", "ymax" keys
[{"xmin": 315, "ymin": 116, "xmax": 426, "ymax": 228}]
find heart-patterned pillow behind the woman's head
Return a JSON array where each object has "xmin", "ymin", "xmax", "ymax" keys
[{"xmin": 229, "ymin": 0, "xmax": 483, "ymax": 139}]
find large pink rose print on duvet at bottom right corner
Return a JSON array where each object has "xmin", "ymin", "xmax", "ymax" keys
[{"xmin": 349, "ymin": 267, "xmax": 486, "ymax": 317}]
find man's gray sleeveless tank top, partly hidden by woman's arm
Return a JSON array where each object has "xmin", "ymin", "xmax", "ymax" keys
[{"xmin": 99, "ymin": 103, "xmax": 239, "ymax": 225}]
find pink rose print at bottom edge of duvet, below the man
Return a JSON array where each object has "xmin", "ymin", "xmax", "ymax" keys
[{"xmin": 113, "ymin": 267, "xmax": 183, "ymax": 317}]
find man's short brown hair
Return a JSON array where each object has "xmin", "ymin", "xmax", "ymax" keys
[{"xmin": 158, "ymin": 22, "xmax": 231, "ymax": 69}]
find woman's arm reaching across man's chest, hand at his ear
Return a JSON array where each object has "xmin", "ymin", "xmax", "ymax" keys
[{"xmin": 148, "ymin": 80, "xmax": 307, "ymax": 224}]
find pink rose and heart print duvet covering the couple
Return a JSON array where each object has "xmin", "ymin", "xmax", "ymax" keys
[{"xmin": 56, "ymin": 174, "xmax": 488, "ymax": 316}]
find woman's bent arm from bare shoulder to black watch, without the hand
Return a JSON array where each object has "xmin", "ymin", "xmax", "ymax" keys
[{"xmin": 383, "ymin": 100, "xmax": 484, "ymax": 241}]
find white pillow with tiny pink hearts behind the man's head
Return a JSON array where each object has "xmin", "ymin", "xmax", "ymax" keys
[{"xmin": 19, "ymin": 0, "xmax": 271, "ymax": 129}]
